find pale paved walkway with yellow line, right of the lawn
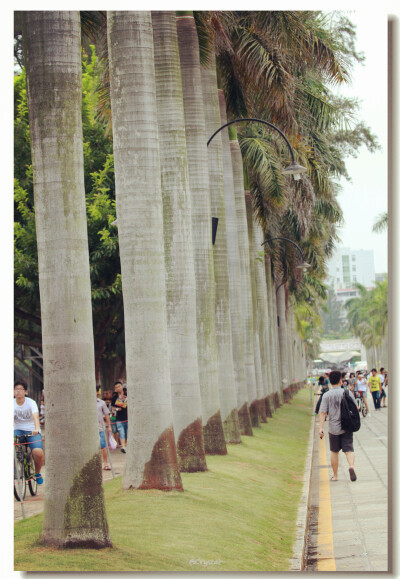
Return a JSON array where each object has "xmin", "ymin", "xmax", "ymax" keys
[{"xmin": 307, "ymin": 394, "xmax": 389, "ymax": 572}]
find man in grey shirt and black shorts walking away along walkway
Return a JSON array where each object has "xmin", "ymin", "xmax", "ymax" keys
[{"xmin": 319, "ymin": 370, "xmax": 357, "ymax": 481}]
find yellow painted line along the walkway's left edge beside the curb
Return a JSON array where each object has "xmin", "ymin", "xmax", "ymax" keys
[{"xmin": 317, "ymin": 439, "xmax": 336, "ymax": 571}]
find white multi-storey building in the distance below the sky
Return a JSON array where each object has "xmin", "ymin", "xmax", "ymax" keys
[{"xmin": 327, "ymin": 247, "xmax": 375, "ymax": 290}]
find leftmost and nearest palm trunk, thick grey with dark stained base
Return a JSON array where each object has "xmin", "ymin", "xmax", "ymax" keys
[{"xmin": 23, "ymin": 11, "xmax": 111, "ymax": 548}]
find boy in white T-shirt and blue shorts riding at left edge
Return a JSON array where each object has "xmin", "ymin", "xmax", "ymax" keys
[{"xmin": 14, "ymin": 380, "xmax": 44, "ymax": 485}]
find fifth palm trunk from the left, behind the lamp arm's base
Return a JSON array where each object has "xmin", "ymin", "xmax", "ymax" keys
[{"xmin": 201, "ymin": 55, "xmax": 240, "ymax": 443}]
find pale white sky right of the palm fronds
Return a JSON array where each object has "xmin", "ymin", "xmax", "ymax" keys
[{"xmin": 330, "ymin": 10, "xmax": 388, "ymax": 273}]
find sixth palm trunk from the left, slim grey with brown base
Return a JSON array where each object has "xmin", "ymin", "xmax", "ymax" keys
[{"xmin": 218, "ymin": 90, "xmax": 251, "ymax": 434}]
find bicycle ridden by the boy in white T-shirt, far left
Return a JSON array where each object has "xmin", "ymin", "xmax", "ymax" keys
[{"xmin": 14, "ymin": 433, "xmax": 37, "ymax": 501}]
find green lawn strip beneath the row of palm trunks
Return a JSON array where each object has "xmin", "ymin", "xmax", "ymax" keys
[{"xmin": 15, "ymin": 389, "xmax": 312, "ymax": 572}]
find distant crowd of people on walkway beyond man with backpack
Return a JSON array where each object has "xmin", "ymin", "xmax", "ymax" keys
[{"xmin": 315, "ymin": 368, "xmax": 389, "ymax": 416}]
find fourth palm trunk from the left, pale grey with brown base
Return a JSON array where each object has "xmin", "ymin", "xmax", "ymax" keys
[{"xmin": 177, "ymin": 15, "xmax": 227, "ymax": 454}]
